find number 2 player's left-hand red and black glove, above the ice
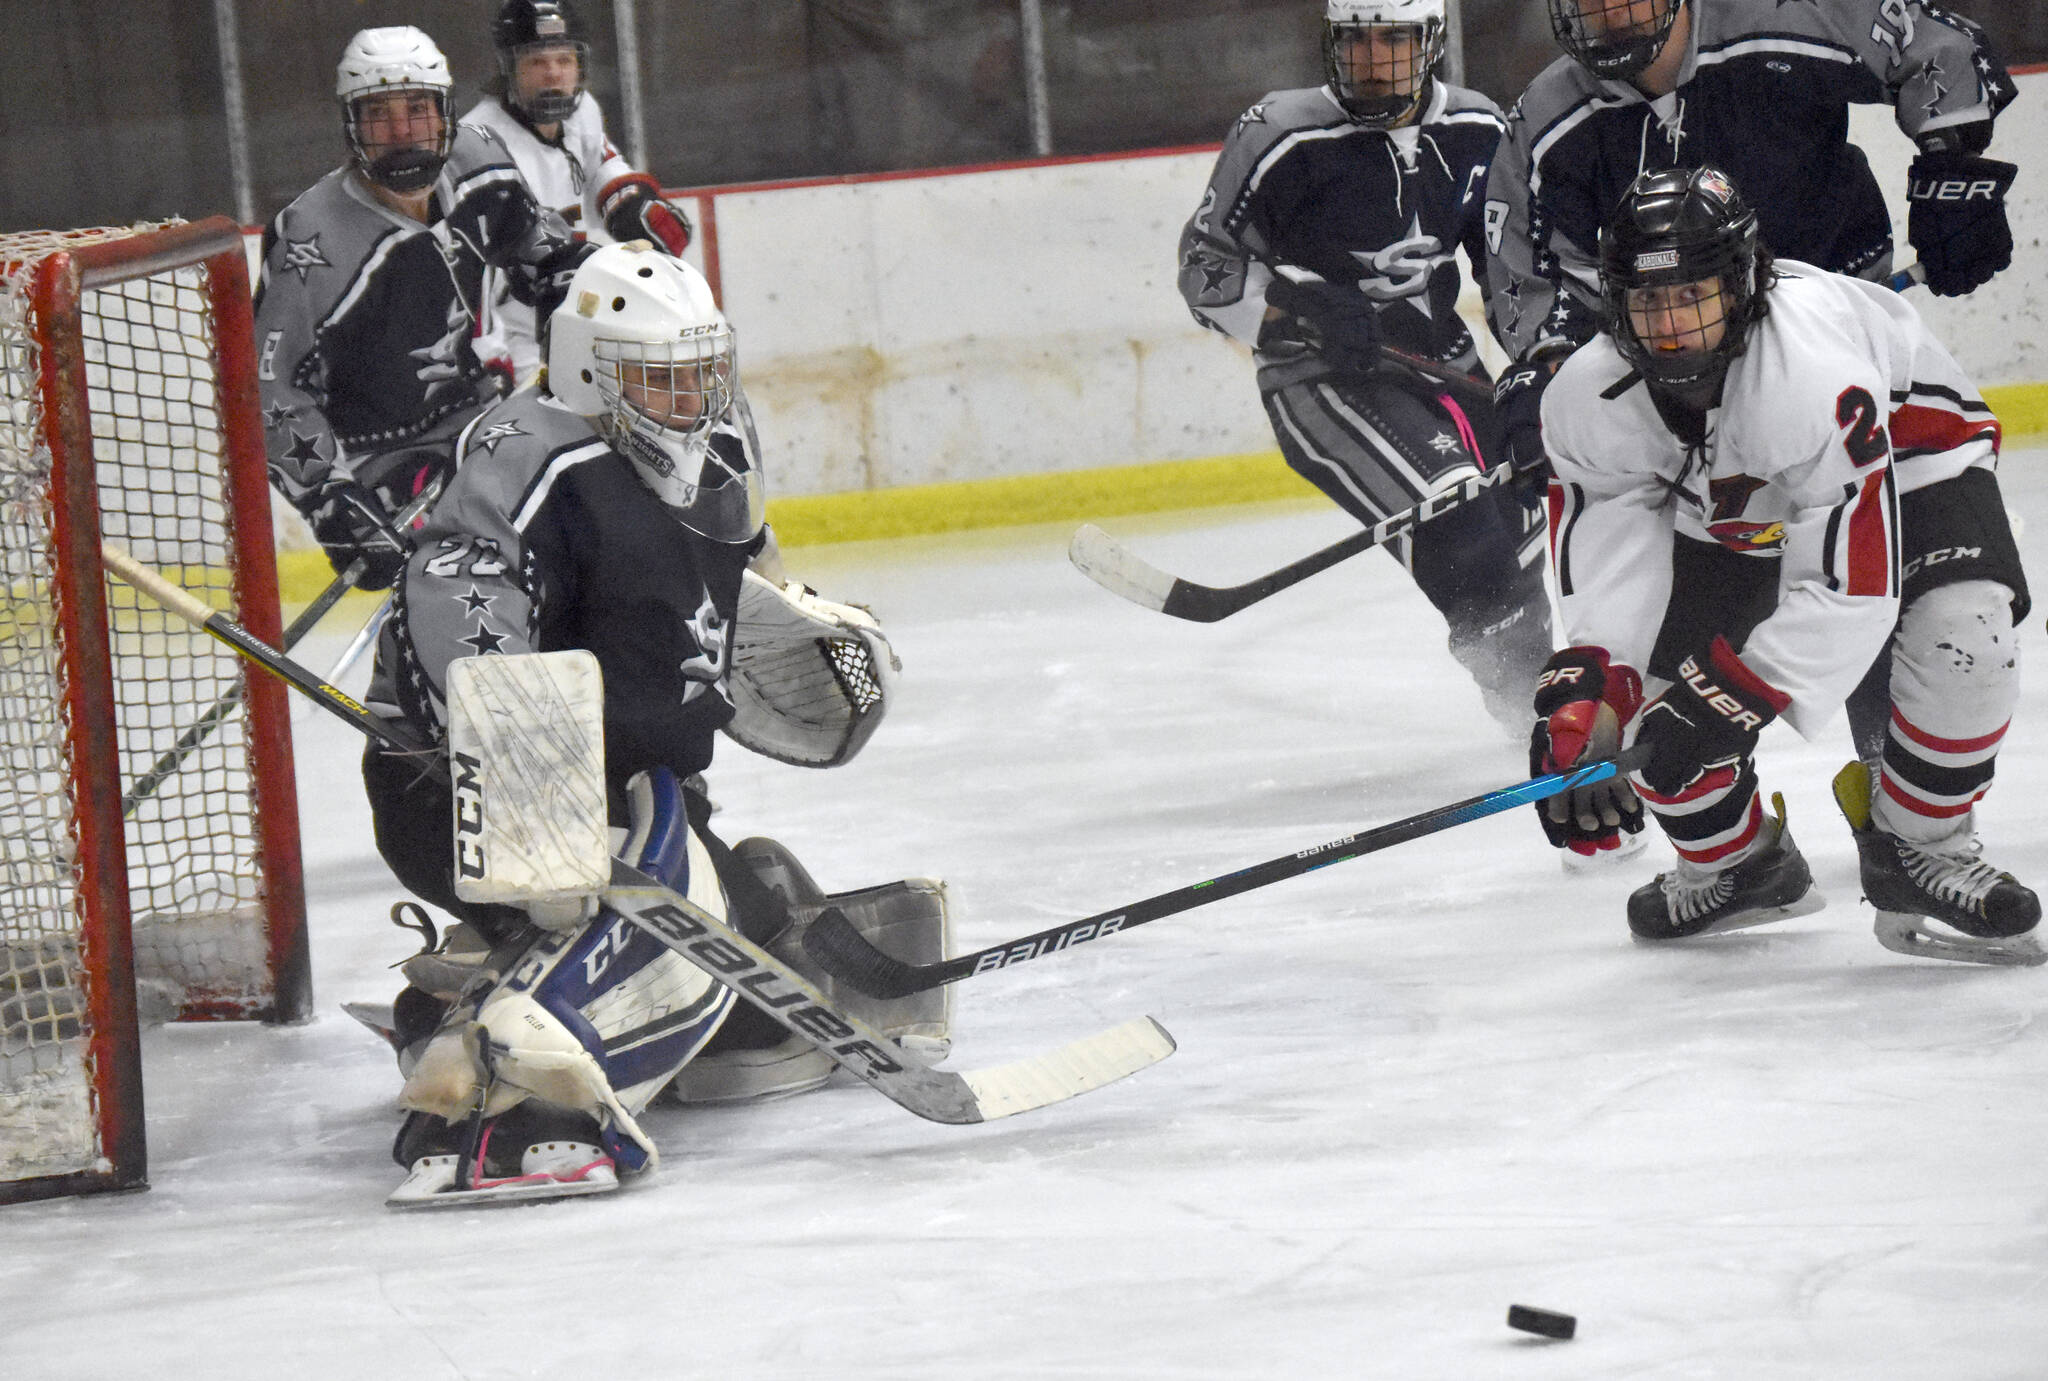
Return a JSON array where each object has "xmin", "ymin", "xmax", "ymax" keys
[{"xmin": 1530, "ymin": 647, "xmax": 1642, "ymax": 856}]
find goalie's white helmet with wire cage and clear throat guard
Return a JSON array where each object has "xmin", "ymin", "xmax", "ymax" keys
[{"xmin": 547, "ymin": 240, "xmax": 766, "ymax": 543}]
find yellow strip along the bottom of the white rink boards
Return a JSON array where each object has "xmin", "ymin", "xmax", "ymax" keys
[{"xmin": 276, "ymin": 383, "xmax": 2048, "ymax": 604}]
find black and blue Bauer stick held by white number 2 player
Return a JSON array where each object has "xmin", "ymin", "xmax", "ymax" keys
[{"xmin": 803, "ymin": 746, "xmax": 1651, "ymax": 998}]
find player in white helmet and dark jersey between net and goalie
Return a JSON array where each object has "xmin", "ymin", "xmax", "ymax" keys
[{"xmin": 256, "ymin": 27, "xmax": 590, "ymax": 590}]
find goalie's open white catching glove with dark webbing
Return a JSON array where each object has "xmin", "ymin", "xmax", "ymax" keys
[{"xmin": 725, "ymin": 570, "xmax": 901, "ymax": 766}]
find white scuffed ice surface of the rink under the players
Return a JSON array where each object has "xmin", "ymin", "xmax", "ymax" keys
[{"xmin": 12, "ymin": 449, "xmax": 2048, "ymax": 1381}]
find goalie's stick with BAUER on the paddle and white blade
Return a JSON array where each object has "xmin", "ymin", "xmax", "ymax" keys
[{"xmin": 100, "ymin": 543, "xmax": 1174, "ymax": 1123}]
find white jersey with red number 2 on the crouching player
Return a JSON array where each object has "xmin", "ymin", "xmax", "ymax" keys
[{"xmin": 1542, "ymin": 260, "xmax": 1999, "ymax": 738}]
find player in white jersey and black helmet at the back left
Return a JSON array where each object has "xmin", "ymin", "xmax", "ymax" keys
[{"xmin": 463, "ymin": 0, "xmax": 690, "ymax": 381}]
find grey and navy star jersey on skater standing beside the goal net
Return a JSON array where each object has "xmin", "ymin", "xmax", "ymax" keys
[{"xmin": 256, "ymin": 127, "xmax": 584, "ymax": 510}]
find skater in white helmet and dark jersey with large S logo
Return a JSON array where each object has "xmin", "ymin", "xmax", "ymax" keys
[{"xmin": 1180, "ymin": 0, "xmax": 1550, "ymax": 731}]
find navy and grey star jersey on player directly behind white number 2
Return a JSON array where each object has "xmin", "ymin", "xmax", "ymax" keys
[{"xmin": 1485, "ymin": 0, "xmax": 2015, "ymax": 359}]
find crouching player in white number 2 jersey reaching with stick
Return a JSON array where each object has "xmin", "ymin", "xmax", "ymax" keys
[{"xmin": 1534, "ymin": 168, "xmax": 2044, "ymax": 963}]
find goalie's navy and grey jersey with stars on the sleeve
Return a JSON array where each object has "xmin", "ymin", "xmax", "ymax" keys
[{"xmin": 365, "ymin": 387, "xmax": 760, "ymax": 791}]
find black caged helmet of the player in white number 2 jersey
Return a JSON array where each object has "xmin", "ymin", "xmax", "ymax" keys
[{"xmin": 1599, "ymin": 168, "xmax": 1772, "ymax": 402}]
